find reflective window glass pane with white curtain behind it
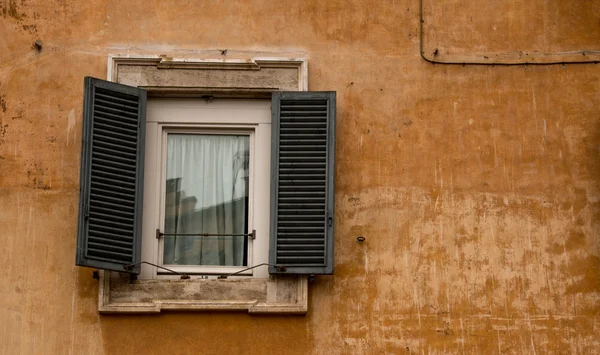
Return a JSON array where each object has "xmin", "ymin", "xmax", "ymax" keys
[{"xmin": 163, "ymin": 134, "xmax": 250, "ymax": 266}]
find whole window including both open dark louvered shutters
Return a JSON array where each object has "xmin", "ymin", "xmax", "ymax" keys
[{"xmin": 77, "ymin": 78, "xmax": 335, "ymax": 276}]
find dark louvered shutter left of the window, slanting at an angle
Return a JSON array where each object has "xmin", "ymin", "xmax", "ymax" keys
[{"xmin": 76, "ymin": 77, "xmax": 146, "ymax": 274}]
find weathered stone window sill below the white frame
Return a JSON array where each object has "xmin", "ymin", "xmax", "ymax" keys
[{"xmin": 98, "ymin": 271, "xmax": 308, "ymax": 314}]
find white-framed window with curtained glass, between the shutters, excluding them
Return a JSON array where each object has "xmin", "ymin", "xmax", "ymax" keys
[{"xmin": 140, "ymin": 98, "xmax": 271, "ymax": 279}]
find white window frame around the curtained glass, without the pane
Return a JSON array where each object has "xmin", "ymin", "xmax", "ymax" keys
[{"xmin": 139, "ymin": 98, "xmax": 271, "ymax": 279}]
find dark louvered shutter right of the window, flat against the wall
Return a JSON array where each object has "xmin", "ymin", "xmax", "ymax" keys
[{"xmin": 269, "ymin": 92, "xmax": 335, "ymax": 274}]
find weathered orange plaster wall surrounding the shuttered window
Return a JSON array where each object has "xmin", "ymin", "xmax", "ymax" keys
[{"xmin": 0, "ymin": 0, "xmax": 600, "ymax": 354}]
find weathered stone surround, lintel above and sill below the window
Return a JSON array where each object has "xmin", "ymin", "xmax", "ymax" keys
[{"xmin": 98, "ymin": 55, "xmax": 308, "ymax": 314}]
